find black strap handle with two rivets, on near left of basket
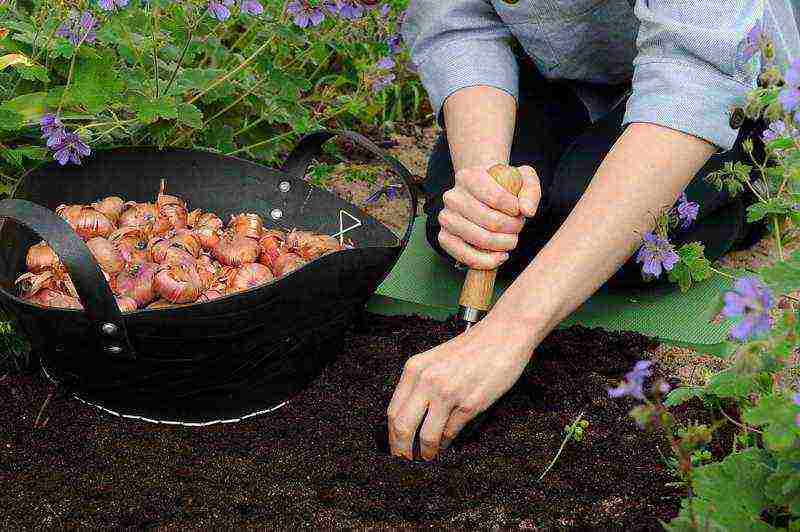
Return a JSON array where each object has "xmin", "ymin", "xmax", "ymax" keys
[{"xmin": 0, "ymin": 199, "xmax": 136, "ymax": 360}]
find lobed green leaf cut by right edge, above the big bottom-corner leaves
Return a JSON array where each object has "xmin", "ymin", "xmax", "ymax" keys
[{"xmin": 742, "ymin": 394, "xmax": 800, "ymax": 452}]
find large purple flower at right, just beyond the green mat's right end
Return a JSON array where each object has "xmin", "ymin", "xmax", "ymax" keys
[{"xmin": 722, "ymin": 277, "xmax": 774, "ymax": 341}]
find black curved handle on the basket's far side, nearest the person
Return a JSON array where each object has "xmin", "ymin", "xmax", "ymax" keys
[{"xmin": 281, "ymin": 129, "xmax": 418, "ymax": 247}]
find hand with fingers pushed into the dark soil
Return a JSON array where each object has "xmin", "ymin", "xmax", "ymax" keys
[{"xmin": 386, "ymin": 313, "xmax": 534, "ymax": 460}]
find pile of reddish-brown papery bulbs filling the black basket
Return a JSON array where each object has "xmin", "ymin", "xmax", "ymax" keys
[{"xmin": 16, "ymin": 180, "xmax": 352, "ymax": 312}]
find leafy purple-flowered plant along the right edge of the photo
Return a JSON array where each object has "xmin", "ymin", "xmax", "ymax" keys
[{"xmin": 610, "ymin": 31, "xmax": 800, "ymax": 530}]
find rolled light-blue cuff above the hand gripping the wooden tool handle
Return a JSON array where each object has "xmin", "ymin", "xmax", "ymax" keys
[{"xmin": 417, "ymin": 41, "xmax": 519, "ymax": 127}]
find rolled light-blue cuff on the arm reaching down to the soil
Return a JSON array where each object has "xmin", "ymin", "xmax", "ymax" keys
[{"xmin": 622, "ymin": 60, "xmax": 754, "ymax": 153}]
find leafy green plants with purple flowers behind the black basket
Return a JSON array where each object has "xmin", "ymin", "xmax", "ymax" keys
[{"xmin": 0, "ymin": 0, "xmax": 422, "ymax": 185}]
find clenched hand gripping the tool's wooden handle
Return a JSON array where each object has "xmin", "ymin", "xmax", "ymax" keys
[{"xmin": 439, "ymin": 166, "xmax": 542, "ymax": 270}]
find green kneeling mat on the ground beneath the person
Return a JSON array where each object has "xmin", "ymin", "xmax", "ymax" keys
[{"xmin": 367, "ymin": 216, "xmax": 731, "ymax": 356}]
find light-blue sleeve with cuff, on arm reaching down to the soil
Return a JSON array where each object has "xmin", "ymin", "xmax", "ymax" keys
[{"xmin": 623, "ymin": 0, "xmax": 764, "ymax": 153}]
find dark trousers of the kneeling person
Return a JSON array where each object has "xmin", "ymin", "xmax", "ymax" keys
[{"xmin": 422, "ymin": 66, "xmax": 766, "ymax": 287}]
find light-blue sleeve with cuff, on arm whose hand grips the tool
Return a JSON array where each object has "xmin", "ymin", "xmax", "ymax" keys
[{"xmin": 401, "ymin": 0, "xmax": 519, "ymax": 125}]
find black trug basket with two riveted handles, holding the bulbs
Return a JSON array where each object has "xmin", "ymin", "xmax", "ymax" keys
[{"xmin": 0, "ymin": 130, "xmax": 417, "ymax": 425}]
